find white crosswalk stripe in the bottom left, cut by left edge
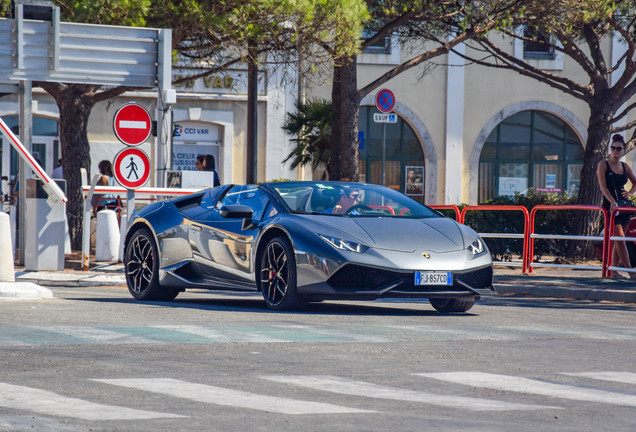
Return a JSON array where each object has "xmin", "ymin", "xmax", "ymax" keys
[{"xmin": 0, "ymin": 383, "xmax": 183, "ymax": 420}]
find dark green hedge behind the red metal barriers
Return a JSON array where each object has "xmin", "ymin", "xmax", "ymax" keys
[{"xmin": 461, "ymin": 189, "xmax": 598, "ymax": 261}]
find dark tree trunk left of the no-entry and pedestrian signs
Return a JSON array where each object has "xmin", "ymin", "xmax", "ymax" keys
[{"xmin": 56, "ymin": 85, "xmax": 94, "ymax": 250}]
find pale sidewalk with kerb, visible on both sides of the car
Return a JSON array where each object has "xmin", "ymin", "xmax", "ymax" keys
[{"xmin": 0, "ymin": 263, "xmax": 636, "ymax": 303}]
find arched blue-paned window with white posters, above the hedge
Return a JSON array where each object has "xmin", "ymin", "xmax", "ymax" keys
[{"xmin": 479, "ymin": 111, "xmax": 583, "ymax": 203}]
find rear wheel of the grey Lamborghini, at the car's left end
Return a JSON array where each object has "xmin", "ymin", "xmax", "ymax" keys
[{"xmin": 124, "ymin": 228, "xmax": 179, "ymax": 301}]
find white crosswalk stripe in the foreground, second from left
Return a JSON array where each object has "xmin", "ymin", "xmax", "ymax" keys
[{"xmin": 93, "ymin": 378, "xmax": 374, "ymax": 414}]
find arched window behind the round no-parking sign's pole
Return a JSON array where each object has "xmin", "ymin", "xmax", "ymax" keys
[{"xmin": 359, "ymin": 106, "xmax": 425, "ymax": 201}]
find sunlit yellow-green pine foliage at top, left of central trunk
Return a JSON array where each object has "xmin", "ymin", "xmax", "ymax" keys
[{"xmin": 149, "ymin": 0, "xmax": 369, "ymax": 67}]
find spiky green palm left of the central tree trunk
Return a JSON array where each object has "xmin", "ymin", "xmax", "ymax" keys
[{"xmin": 283, "ymin": 99, "xmax": 332, "ymax": 177}]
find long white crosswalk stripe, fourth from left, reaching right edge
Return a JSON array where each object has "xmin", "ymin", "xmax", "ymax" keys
[{"xmin": 413, "ymin": 372, "xmax": 636, "ymax": 407}]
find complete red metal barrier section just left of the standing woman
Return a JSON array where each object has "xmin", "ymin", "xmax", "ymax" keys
[{"xmin": 528, "ymin": 204, "xmax": 613, "ymax": 277}]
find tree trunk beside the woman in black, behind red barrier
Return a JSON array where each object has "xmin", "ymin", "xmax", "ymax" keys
[{"xmin": 568, "ymin": 103, "xmax": 613, "ymax": 258}]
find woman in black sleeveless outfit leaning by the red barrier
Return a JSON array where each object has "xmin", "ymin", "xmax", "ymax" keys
[{"xmin": 596, "ymin": 134, "xmax": 636, "ymax": 279}]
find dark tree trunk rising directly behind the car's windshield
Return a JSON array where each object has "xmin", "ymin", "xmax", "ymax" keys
[{"xmin": 329, "ymin": 57, "xmax": 360, "ymax": 181}]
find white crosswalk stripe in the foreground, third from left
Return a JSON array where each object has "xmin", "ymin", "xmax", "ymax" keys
[{"xmin": 262, "ymin": 376, "xmax": 558, "ymax": 411}]
